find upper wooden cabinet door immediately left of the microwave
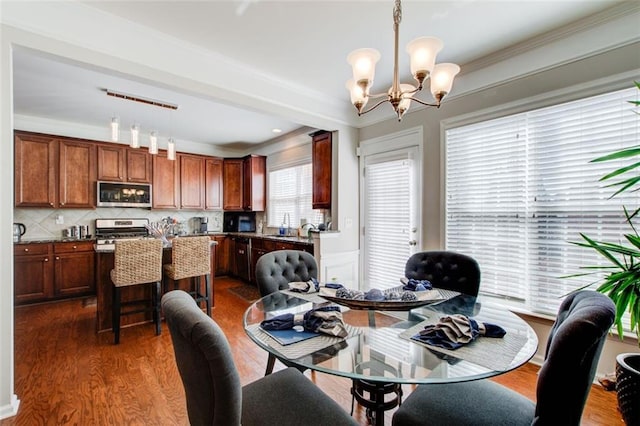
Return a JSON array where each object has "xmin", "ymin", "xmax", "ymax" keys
[{"xmin": 58, "ymin": 140, "xmax": 97, "ymax": 208}]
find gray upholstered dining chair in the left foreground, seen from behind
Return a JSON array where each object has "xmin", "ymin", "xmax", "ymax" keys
[{"xmin": 162, "ymin": 290, "xmax": 356, "ymax": 426}]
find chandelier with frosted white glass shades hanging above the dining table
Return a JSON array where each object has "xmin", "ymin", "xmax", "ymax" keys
[{"xmin": 347, "ymin": 0, "xmax": 460, "ymax": 121}]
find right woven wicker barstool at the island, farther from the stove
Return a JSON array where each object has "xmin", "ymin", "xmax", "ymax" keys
[{"xmin": 164, "ymin": 236, "xmax": 212, "ymax": 316}]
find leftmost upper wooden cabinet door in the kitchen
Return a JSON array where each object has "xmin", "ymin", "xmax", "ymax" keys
[{"xmin": 14, "ymin": 132, "xmax": 57, "ymax": 208}]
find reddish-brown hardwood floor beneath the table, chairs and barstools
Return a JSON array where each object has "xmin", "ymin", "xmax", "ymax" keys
[{"xmin": 0, "ymin": 278, "xmax": 623, "ymax": 426}]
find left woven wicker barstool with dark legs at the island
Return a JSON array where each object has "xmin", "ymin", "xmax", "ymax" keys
[{"xmin": 111, "ymin": 239, "xmax": 162, "ymax": 344}]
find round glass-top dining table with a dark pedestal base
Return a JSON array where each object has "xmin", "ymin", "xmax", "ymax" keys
[{"xmin": 243, "ymin": 289, "xmax": 538, "ymax": 424}]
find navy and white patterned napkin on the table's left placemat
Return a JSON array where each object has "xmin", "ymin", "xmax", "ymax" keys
[{"xmin": 260, "ymin": 306, "xmax": 349, "ymax": 337}]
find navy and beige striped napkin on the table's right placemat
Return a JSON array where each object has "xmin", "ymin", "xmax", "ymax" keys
[{"xmin": 413, "ymin": 314, "xmax": 507, "ymax": 350}]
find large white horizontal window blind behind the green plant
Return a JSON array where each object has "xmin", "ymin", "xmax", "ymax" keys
[{"xmin": 445, "ymin": 88, "xmax": 640, "ymax": 315}]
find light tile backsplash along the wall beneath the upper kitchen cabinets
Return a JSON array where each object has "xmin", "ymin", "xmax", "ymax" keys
[{"xmin": 13, "ymin": 207, "xmax": 223, "ymax": 240}]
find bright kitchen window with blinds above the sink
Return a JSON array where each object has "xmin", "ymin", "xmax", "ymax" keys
[{"xmin": 267, "ymin": 163, "xmax": 323, "ymax": 228}]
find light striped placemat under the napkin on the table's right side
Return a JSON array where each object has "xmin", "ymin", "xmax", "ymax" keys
[{"xmin": 399, "ymin": 316, "xmax": 527, "ymax": 371}]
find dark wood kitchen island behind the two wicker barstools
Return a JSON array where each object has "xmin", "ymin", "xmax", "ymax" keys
[{"xmin": 95, "ymin": 237, "xmax": 217, "ymax": 333}]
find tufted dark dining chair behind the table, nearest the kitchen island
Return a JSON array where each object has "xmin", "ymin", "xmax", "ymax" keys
[{"xmin": 256, "ymin": 250, "xmax": 318, "ymax": 376}]
